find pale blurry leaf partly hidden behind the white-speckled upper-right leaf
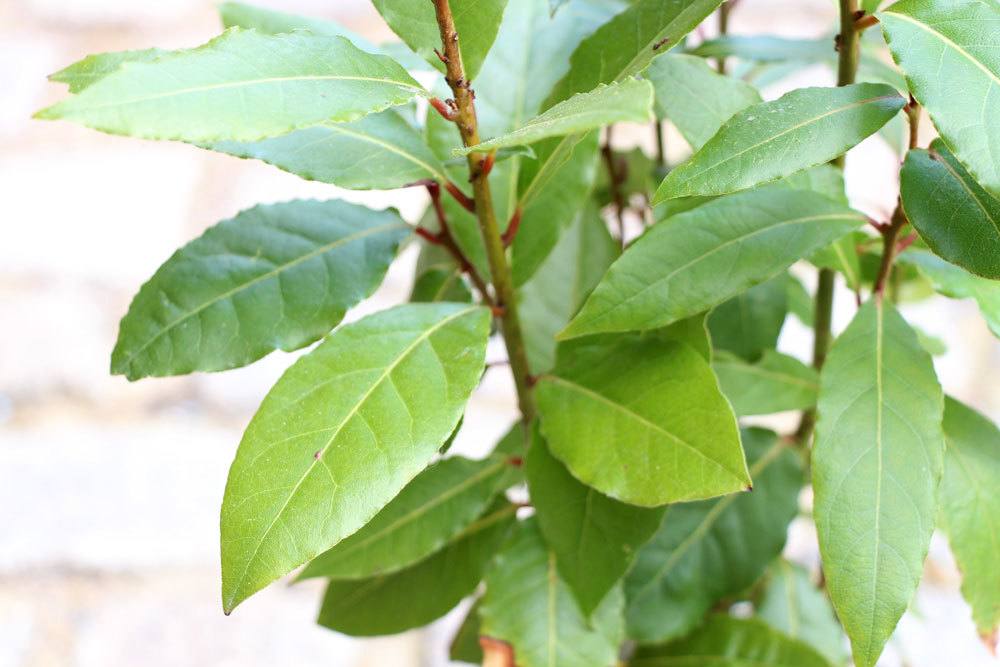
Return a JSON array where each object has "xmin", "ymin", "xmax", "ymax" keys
[{"xmin": 646, "ymin": 54, "xmax": 761, "ymax": 150}]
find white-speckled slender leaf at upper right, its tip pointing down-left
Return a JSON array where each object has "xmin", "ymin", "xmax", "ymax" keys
[{"xmin": 653, "ymin": 83, "xmax": 905, "ymax": 204}]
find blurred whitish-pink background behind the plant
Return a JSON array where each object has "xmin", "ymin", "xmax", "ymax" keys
[{"xmin": 0, "ymin": 0, "xmax": 1000, "ymax": 667}]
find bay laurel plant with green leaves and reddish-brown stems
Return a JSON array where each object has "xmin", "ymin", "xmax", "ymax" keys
[{"xmin": 38, "ymin": 0, "xmax": 1000, "ymax": 667}]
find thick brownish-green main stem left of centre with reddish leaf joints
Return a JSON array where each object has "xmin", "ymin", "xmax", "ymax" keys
[{"xmin": 434, "ymin": 0, "xmax": 535, "ymax": 423}]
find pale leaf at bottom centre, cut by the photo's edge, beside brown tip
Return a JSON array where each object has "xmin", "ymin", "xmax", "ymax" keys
[{"xmin": 480, "ymin": 519, "xmax": 625, "ymax": 667}]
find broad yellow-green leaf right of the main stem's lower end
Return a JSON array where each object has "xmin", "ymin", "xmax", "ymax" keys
[{"xmin": 535, "ymin": 335, "xmax": 750, "ymax": 507}]
